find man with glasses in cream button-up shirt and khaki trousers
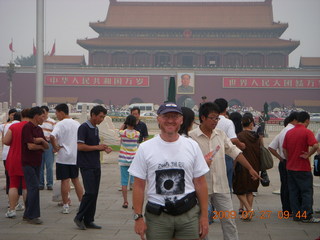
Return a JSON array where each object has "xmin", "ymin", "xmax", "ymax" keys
[{"xmin": 189, "ymin": 102, "xmax": 260, "ymax": 240}]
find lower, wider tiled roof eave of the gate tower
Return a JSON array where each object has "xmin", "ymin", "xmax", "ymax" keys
[{"xmin": 77, "ymin": 37, "xmax": 300, "ymax": 52}]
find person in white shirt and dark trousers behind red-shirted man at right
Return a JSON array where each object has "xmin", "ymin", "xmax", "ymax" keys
[{"xmin": 268, "ymin": 112, "xmax": 298, "ymax": 213}]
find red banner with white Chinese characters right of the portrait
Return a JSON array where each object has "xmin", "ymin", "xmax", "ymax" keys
[{"xmin": 223, "ymin": 77, "xmax": 320, "ymax": 89}]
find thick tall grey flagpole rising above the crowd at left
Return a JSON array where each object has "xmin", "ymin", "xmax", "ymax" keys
[{"xmin": 36, "ymin": 0, "xmax": 44, "ymax": 106}]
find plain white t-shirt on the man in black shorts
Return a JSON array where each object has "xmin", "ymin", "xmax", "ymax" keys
[{"xmin": 51, "ymin": 118, "xmax": 80, "ymax": 165}]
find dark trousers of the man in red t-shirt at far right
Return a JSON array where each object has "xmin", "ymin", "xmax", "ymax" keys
[{"xmin": 288, "ymin": 170, "xmax": 313, "ymax": 220}]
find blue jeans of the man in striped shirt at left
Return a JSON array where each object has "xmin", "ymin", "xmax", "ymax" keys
[{"xmin": 39, "ymin": 143, "xmax": 54, "ymax": 187}]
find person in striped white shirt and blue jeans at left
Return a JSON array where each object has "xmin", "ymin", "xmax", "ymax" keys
[{"xmin": 39, "ymin": 106, "xmax": 56, "ymax": 190}]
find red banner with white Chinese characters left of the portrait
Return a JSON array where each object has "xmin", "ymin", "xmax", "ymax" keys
[{"xmin": 44, "ymin": 75, "xmax": 149, "ymax": 87}]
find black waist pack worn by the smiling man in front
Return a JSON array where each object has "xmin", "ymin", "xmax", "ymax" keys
[{"xmin": 146, "ymin": 192, "xmax": 197, "ymax": 216}]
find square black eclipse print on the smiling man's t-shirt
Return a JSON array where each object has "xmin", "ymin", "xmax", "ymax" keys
[{"xmin": 156, "ymin": 169, "xmax": 185, "ymax": 195}]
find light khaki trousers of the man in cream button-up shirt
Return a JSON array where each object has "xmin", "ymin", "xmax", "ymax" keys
[{"xmin": 209, "ymin": 193, "xmax": 239, "ymax": 240}]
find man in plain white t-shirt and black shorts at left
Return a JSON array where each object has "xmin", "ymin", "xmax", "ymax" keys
[{"xmin": 50, "ymin": 103, "xmax": 83, "ymax": 214}]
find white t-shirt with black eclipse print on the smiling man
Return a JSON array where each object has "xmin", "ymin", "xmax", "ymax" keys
[{"xmin": 128, "ymin": 135, "xmax": 209, "ymax": 206}]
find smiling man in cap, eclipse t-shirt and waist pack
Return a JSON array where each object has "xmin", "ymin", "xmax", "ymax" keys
[{"xmin": 129, "ymin": 103, "xmax": 209, "ymax": 240}]
